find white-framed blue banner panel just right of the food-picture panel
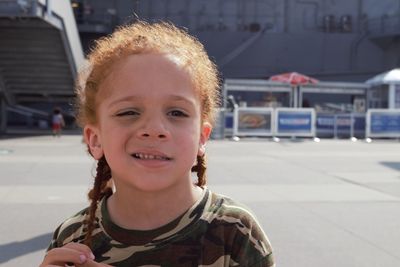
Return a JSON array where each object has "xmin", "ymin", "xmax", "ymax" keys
[{"xmin": 276, "ymin": 109, "xmax": 315, "ymax": 136}]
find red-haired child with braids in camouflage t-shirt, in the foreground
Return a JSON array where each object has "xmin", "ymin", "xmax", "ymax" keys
[{"xmin": 41, "ymin": 22, "xmax": 274, "ymax": 267}]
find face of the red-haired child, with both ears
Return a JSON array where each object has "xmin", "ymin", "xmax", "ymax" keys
[{"xmin": 85, "ymin": 54, "xmax": 211, "ymax": 194}]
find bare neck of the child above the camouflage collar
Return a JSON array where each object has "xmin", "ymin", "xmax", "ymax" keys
[{"xmin": 107, "ymin": 184, "xmax": 203, "ymax": 230}]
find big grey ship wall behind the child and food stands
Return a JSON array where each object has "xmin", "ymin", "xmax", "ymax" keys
[{"xmin": 72, "ymin": 0, "xmax": 400, "ymax": 82}]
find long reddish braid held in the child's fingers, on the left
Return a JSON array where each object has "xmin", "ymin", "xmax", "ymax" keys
[{"xmin": 84, "ymin": 156, "xmax": 112, "ymax": 247}]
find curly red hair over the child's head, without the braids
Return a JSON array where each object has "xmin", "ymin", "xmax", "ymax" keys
[{"xmin": 76, "ymin": 21, "xmax": 219, "ymax": 126}]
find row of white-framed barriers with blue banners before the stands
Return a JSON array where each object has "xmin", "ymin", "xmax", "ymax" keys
[{"xmin": 213, "ymin": 107, "xmax": 400, "ymax": 139}]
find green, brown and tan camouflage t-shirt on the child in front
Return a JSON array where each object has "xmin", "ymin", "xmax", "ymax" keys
[{"xmin": 49, "ymin": 189, "xmax": 275, "ymax": 267}]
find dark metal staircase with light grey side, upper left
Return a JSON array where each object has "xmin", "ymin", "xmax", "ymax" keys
[{"xmin": 0, "ymin": 0, "xmax": 83, "ymax": 132}]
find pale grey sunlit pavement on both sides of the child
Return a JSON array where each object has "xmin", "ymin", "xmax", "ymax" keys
[{"xmin": 0, "ymin": 136, "xmax": 400, "ymax": 267}]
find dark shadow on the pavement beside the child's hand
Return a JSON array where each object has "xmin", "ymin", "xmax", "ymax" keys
[{"xmin": 0, "ymin": 233, "xmax": 53, "ymax": 263}]
